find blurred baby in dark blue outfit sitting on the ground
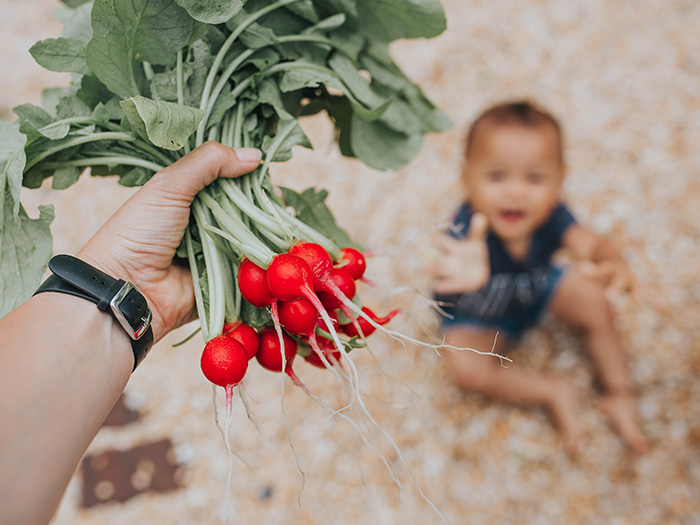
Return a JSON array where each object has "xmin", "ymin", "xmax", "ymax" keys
[{"xmin": 432, "ymin": 102, "xmax": 648, "ymax": 455}]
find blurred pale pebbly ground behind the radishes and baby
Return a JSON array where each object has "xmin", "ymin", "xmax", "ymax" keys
[{"xmin": 0, "ymin": 0, "xmax": 700, "ymax": 525}]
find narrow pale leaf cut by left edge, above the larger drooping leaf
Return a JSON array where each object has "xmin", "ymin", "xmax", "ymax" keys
[{"xmin": 0, "ymin": 119, "xmax": 27, "ymax": 216}]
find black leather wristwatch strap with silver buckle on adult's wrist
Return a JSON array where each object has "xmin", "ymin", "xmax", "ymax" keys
[{"xmin": 34, "ymin": 255, "xmax": 153, "ymax": 371}]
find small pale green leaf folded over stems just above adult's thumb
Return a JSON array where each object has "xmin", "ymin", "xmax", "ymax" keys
[{"xmin": 121, "ymin": 96, "xmax": 204, "ymax": 151}]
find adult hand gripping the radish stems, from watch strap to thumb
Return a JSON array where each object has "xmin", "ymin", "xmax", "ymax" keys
[{"xmin": 78, "ymin": 142, "xmax": 261, "ymax": 341}]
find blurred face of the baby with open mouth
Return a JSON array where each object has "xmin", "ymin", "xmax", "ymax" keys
[{"xmin": 463, "ymin": 124, "xmax": 564, "ymax": 242}]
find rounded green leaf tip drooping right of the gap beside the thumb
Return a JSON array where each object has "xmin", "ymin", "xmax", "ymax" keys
[{"xmin": 350, "ymin": 115, "xmax": 423, "ymax": 171}]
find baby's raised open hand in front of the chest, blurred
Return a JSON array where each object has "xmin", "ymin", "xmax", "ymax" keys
[{"xmin": 429, "ymin": 213, "xmax": 491, "ymax": 294}]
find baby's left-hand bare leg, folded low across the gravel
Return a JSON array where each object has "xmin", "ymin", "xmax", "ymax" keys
[{"xmin": 444, "ymin": 327, "xmax": 581, "ymax": 455}]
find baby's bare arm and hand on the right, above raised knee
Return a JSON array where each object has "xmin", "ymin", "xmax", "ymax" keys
[{"xmin": 562, "ymin": 224, "xmax": 637, "ymax": 299}]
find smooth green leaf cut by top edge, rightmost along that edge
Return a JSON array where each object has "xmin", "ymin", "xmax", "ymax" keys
[{"xmin": 357, "ymin": 0, "xmax": 447, "ymax": 42}]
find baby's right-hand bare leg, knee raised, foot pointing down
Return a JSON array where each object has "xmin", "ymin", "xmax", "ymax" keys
[{"xmin": 550, "ymin": 270, "xmax": 648, "ymax": 453}]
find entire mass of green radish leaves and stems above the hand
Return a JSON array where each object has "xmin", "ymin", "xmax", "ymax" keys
[{"xmin": 0, "ymin": 0, "xmax": 450, "ymax": 316}]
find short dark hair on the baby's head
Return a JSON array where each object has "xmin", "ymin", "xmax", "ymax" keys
[{"xmin": 464, "ymin": 100, "xmax": 564, "ymax": 164}]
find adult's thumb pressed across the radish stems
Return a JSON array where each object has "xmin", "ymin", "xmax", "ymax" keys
[{"xmin": 144, "ymin": 141, "xmax": 262, "ymax": 204}]
